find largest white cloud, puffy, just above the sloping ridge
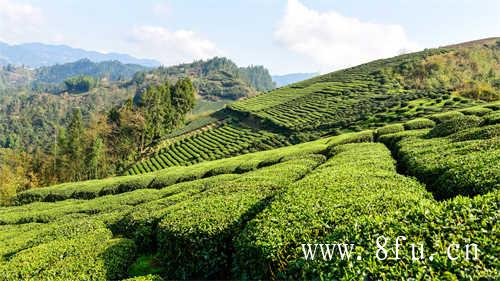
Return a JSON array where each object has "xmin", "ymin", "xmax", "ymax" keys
[{"xmin": 274, "ymin": 0, "xmax": 418, "ymax": 70}]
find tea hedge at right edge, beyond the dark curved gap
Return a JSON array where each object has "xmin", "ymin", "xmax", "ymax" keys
[{"xmin": 385, "ymin": 124, "xmax": 500, "ymax": 198}]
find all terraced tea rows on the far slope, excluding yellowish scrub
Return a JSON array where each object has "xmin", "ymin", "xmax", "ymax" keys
[{"xmin": 127, "ymin": 46, "xmax": 493, "ymax": 174}]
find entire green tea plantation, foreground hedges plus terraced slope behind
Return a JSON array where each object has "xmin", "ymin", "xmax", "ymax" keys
[{"xmin": 0, "ymin": 38, "xmax": 500, "ymax": 281}]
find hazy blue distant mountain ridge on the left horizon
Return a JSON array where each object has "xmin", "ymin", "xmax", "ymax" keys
[{"xmin": 0, "ymin": 42, "xmax": 160, "ymax": 68}]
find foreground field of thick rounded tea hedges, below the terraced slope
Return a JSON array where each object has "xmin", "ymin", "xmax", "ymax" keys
[{"xmin": 0, "ymin": 102, "xmax": 500, "ymax": 280}]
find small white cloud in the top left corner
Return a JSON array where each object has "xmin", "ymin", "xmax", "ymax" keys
[{"xmin": 0, "ymin": 0, "xmax": 45, "ymax": 43}]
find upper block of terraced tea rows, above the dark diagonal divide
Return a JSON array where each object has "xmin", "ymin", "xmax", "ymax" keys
[{"xmin": 228, "ymin": 47, "xmax": 464, "ymax": 132}]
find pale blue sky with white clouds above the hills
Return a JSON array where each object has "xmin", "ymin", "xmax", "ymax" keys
[{"xmin": 0, "ymin": 0, "xmax": 500, "ymax": 74}]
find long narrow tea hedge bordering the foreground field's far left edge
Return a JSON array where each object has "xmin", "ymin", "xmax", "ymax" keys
[{"xmin": 13, "ymin": 137, "xmax": 328, "ymax": 205}]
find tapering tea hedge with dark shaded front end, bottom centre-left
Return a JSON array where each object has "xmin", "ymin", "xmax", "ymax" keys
[{"xmin": 158, "ymin": 155, "xmax": 324, "ymax": 279}]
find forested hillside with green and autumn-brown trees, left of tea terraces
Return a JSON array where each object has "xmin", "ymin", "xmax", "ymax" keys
[{"xmin": 0, "ymin": 55, "xmax": 272, "ymax": 191}]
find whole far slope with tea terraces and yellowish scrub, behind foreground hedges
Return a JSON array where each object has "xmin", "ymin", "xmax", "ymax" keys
[{"xmin": 129, "ymin": 39, "xmax": 500, "ymax": 173}]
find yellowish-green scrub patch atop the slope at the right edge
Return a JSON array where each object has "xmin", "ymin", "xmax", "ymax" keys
[{"xmin": 388, "ymin": 41, "xmax": 500, "ymax": 101}]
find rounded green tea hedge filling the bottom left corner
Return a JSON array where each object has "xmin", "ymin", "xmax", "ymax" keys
[{"xmin": 0, "ymin": 221, "xmax": 136, "ymax": 281}]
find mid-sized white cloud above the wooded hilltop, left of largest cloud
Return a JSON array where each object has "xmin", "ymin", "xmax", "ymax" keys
[{"xmin": 129, "ymin": 26, "xmax": 220, "ymax": 65}]
